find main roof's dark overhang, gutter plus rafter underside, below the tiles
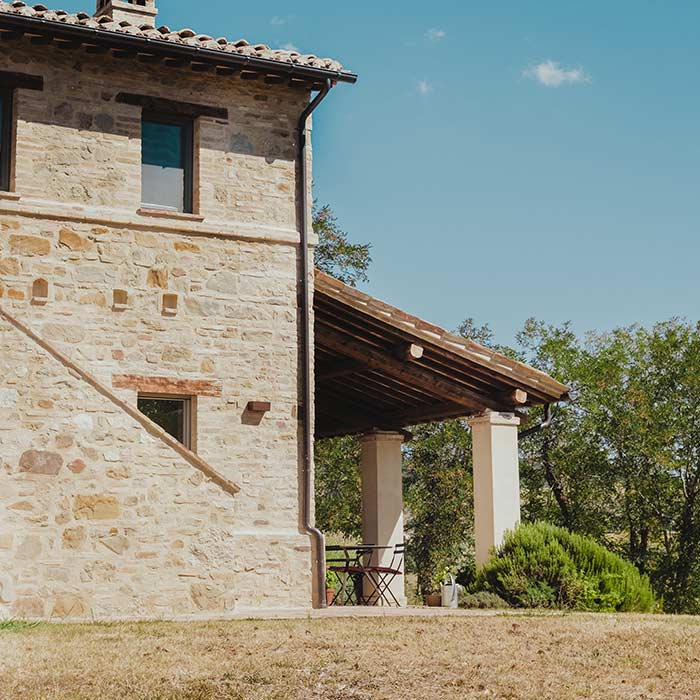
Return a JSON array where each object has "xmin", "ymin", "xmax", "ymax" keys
[{"xmin": 0, "ymin": 12, "xmax": 357, "ymax": 90}]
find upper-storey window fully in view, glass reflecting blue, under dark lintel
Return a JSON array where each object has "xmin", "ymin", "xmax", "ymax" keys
[{"xmin": 141, "ymin": 114, "xmax": 193, "ymax": 213}]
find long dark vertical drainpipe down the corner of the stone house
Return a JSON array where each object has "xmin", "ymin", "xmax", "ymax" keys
[{"xmin": 298, "ymin": 79, "xmax": 333, "ymax": 608}]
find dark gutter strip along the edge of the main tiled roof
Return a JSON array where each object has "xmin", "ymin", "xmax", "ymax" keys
[{"xmin": 0, "ymin": 13, "xmax": 357, "ymax": 84}]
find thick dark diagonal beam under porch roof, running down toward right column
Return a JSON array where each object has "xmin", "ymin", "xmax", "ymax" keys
[{"xmin": 316, "ymin": 324, "xmax": 494, "ymax": 411}]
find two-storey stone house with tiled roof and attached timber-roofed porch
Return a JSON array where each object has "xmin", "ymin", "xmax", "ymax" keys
[{"xmin": 0, "ymin": 0, "xmax": 566, "ymax": 619}]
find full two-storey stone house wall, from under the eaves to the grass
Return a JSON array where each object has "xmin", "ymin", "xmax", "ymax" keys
[{"xmin": 0, "ymin": 42, "xmax": 311, "ymax": 618}]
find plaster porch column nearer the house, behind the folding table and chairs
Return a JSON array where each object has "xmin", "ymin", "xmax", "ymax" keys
[{"xmin": 360, "ymin": 431, "xmax": 406, "ymax": 605}]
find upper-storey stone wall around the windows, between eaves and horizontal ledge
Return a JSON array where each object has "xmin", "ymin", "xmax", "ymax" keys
[{"xmin": 5, "ymin": 42, "xmax": 308, "ymax": 228}]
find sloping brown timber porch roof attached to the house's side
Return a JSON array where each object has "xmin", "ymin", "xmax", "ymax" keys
[{"xmin": 314, "ymin": 270, "xmax": 568, "ymax": 438}]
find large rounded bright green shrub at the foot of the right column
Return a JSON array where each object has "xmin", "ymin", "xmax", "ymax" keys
[{"xmin": 479, "ymin": 523, "xmax": 656, "ymax": 612}]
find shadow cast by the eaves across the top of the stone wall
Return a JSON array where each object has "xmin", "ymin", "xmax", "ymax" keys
[{"xmin": 11, "ymin": 43, "xmax": 298, "ymax": 164}]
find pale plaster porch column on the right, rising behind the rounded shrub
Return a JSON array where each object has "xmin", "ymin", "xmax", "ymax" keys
[{"xmin": 469, "ymin": 411, "xmax": 520, "ymax": 566}]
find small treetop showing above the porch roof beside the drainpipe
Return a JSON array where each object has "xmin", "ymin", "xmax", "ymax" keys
[{"xmin": 314, "ymin": 205, "xmax": 372, "ymax": 287}]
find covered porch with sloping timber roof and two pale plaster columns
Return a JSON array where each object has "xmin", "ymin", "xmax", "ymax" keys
[{"xmin": 314, "ymin": 271, "xmax": 568, "ymax": 607}]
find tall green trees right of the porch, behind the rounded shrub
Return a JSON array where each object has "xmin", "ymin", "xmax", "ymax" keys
[{"xmin": 519, "ymin": 320, "xmax": 700, "ymax": 613}]
